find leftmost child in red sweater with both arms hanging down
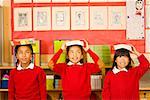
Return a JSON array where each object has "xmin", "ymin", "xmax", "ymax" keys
[{"xmin": 8, "ymin": 44, "xmax": 46, "ymax": 100}]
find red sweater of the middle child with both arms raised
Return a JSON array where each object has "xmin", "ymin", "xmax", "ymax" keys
[{"xmin": 52, "ymin": 50, "xmax": 100, "ymax": 100}]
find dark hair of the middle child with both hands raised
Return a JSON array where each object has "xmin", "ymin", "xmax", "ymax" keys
[{"xmin": 66, "ymin": 45, "xmax": 87, "ymax": 63}]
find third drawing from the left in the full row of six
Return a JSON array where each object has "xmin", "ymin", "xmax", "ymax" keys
[{"xmin": 52, "ymin": 7, "xmax": 70, "ymax": 30}]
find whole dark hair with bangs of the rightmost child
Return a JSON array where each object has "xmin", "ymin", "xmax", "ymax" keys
[{"xmin": 112, "ymin": 48, "xmax": 132, "ymax": 70}]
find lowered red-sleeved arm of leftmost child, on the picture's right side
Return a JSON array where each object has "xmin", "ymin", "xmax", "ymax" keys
[{"xmin": 38, "ymin": 69, "xmax": 47, "ymax": 100}]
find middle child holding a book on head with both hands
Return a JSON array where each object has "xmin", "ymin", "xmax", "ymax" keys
[{"xmin": 48, "ymin": 40, "xmax": 104, "ymax": 100}]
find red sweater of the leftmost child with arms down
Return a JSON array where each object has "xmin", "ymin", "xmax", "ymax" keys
[{"xmin": 8, "ymin": 66, "xmax": 46, "ymax": 100}]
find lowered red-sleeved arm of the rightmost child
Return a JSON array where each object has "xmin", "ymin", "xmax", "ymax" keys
[{"xmin": 102, "ymin": 72, "xmax": 110, "ymax": 100}]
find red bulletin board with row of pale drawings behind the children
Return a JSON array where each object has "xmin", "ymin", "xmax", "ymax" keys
[{"xmin": 11, "ymin": 0, "xmax": 145, "ymax": 54}]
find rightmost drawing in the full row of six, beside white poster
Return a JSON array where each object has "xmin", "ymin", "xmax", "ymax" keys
[{"xmin": 108, "ymin": 6, "xmax": 126, "ymax": 30}]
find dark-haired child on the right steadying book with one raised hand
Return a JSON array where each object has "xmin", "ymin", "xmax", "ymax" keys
[{"xmin": 102, "ymin": 45, "xmax": 149, "ymax": 100}]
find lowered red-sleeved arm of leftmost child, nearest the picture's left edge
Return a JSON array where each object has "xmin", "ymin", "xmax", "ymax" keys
[{"xmin": 8, "ymin": 70, "xmax": 15, "ymax": 100}]
